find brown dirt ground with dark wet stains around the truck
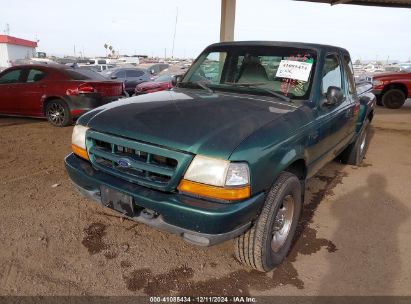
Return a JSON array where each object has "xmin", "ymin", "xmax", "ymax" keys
[{"xmin": 0, "ymin": 100, "xmax": 411, "ymax": 296}]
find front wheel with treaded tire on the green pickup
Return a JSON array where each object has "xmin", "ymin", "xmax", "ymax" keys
[{"xmin": 234, "ymin": 172, "xmax": 302, "ymax": 272}]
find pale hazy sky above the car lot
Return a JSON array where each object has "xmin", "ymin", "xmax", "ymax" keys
[{"xmin": 0, "ymin": 0, "xmax": 411, "ymax": 61}]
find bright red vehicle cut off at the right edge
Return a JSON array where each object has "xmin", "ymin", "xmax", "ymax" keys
[{"xmin": 372, "ymin": 70, "xmax": 411, "ymax": 109}]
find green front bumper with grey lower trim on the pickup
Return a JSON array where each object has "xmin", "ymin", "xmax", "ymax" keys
[{"xmin": 65, "ymin": 154, "xmax": 265, "ymax": 246}]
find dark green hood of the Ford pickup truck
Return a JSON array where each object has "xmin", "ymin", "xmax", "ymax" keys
[{"xmin": 78, "ymin": 89, "xmax": 297, "ymax": 159}]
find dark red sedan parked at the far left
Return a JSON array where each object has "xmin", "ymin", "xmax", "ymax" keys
[{"xmin": 0, "ymin": 65, "xmax": 124, "ymax": 127}]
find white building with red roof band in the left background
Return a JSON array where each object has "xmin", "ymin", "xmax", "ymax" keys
[{"xmin": 0, "ymin": 35, "xmax": 37, "ymax": 67}]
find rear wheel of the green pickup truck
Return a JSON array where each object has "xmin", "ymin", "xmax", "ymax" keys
[{"xmin": 340, "ymin": 119, "xmax": 370, "ymax": 166}]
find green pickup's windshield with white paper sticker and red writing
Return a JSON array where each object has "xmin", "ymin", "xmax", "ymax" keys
[{"xmin": 180, "ymin": 46, "xmax": 317, "ymax": 99}]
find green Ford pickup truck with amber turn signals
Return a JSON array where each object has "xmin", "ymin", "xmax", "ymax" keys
[{"xmin": 65, "ymin": 41, "xmax": 375, "ymax": 271}]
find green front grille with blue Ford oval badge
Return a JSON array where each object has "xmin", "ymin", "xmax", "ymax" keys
[{"xmin": 86, "ymin": 131, "xmax": 192, "ymax": 191}]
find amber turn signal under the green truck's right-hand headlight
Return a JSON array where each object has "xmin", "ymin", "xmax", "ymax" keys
[{"xmin": 177, "ymin": 179, "xmax": 251, "ymax": 201}]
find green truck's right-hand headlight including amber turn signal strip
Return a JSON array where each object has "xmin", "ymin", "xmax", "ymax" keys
[{"xmin": 178, "ymin": 155, "xmax": 250, "ymax": 200}]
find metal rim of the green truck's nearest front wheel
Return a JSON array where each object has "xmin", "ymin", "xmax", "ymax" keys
[{"xmin": 271, "ymin": 195, "xmax": 295, "ymax": 252}]
